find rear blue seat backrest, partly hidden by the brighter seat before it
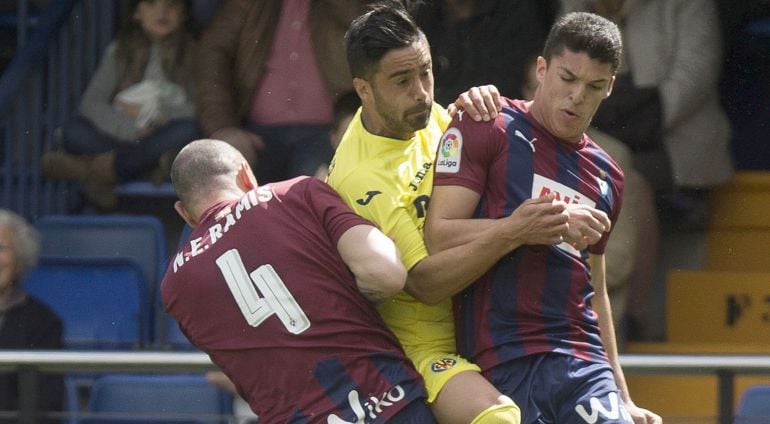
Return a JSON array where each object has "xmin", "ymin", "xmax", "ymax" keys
[{"xmin": 35, "ymin": 215, "xmax": 168, "ymax": 301}]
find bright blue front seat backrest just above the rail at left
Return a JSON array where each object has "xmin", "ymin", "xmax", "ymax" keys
[{"xmin": 22, "ymin": 257, "xmax": 152, "ymax": 349}]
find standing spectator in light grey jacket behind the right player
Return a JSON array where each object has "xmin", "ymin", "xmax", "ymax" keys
[{"xmin": 562, "ymin": 0, "xmax": 733, "ymax": 339}]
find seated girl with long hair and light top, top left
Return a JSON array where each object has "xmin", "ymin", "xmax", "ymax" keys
[{"xmin": 42, "ymin": 0, "xmax": 200, "ymax": 209}]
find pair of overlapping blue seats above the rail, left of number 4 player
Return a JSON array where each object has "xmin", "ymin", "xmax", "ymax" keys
[{"xmin": 24, "ymin": 215, "xmax": 192, "ymax": 349}]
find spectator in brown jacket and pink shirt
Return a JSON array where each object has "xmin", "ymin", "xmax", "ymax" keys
[{"xmin": 196, "ymin": 0, "xmax": 364, "ymax": 182}]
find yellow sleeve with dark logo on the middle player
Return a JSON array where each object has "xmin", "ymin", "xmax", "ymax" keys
[{"xmin": 332, "ymin": 168, "xmax": 428, "ymax": 269}]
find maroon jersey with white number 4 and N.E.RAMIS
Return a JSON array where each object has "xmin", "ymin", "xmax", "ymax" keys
[{"xmin": 161, "ymin": 177, "xmax": 425, "ymax": 423}]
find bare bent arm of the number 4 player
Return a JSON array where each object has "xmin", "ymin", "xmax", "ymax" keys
[{"xmin": 337, "ymin": 225, "xmax": 406, "ymax": 303}]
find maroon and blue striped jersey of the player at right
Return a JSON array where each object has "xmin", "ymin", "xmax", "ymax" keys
[{"xmin": 434, "ymin": 99, "xmax": 623, "ymax": 370}]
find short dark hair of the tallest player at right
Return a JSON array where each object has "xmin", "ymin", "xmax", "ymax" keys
[{"xmin": 543, "ymin": 12, "xmax": 623, "ymax": 73}]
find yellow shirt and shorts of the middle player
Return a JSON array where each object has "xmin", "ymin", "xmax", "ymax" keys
[{"xmin": 327, "ymin": 103, "xmax": 478, "ymax": 400}]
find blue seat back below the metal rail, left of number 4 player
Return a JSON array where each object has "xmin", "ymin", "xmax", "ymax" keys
[{"xmin": 78, "ymin": 374, "xmax": 233, "ymax": 424}]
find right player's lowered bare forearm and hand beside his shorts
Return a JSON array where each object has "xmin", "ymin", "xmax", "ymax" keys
[{"xmin": 588, "ymin": 254, "xmax": 662, "ymax": 424}]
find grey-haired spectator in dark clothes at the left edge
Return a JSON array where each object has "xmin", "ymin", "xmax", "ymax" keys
[{"xmin": 0, "ymin": 209, "xmax": 64, "ymax": 422}]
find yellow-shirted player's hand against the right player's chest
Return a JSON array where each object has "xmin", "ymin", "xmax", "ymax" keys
[{"xmin": 505, "ymin": 194, "xmax": 569, "ymax": 245}]
